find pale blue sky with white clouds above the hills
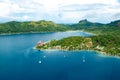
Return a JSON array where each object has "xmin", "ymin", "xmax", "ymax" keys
[{"xmin": 0, "ymin": 0, "xmax": 120, "ymax": 23}]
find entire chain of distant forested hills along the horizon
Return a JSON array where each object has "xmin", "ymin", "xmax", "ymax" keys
[{"xmin": 0, "ymin": 19, "xmax": 120, "ymax": 34}]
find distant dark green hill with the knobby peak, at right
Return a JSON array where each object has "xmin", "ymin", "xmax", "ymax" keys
[{"xmin": 70, "ymin": 19, "xmax": 120, "ymax": 35}]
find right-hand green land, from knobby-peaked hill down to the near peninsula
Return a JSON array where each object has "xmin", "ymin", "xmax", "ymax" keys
[{"xmin": 36, "ymin": 19, "xmax": 120, "ymax": 56}]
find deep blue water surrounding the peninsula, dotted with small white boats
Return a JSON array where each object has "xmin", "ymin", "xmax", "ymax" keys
[{"xmin": 0, "ymin": 32, "xmax": 120, "ymax": 80}]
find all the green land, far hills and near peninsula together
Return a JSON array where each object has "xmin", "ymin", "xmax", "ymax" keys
[{"xmin": 0, "ymin": 19, "xmax": 120, "ymax": 56}]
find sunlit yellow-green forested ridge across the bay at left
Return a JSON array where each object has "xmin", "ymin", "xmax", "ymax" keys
[{"xmin": 0, "ymin": 20, "xmax": 68, "ymax": 34}]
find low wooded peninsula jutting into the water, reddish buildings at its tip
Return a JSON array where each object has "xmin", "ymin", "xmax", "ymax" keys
[{"xmin": 36, "ymin": 35, "xmax": 120, "ymax": 56}]
